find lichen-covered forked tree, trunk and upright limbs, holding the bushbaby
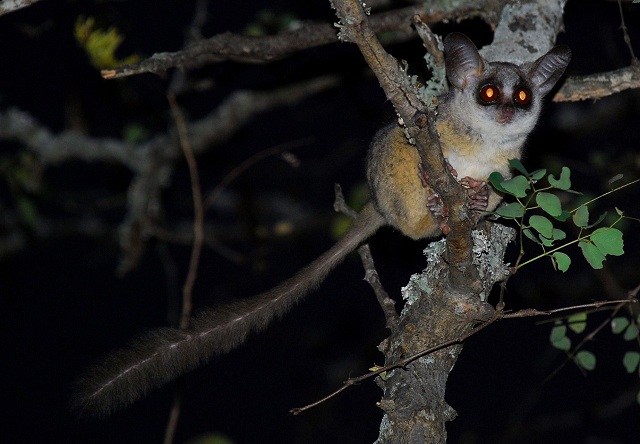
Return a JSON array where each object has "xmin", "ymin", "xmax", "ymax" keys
[{"xmin": 332, "ymin": 0, "xmax": 564, "ymax": 444}]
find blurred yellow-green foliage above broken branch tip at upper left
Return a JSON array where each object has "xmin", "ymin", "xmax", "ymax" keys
[{"xmin": 74, "ymin": 16, "xmax": 139, "ymax": 69}]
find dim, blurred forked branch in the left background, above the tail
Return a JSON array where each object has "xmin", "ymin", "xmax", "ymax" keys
[{"xmin": 0, "ymin": 76, "xmax": 339, "ymax": 274}]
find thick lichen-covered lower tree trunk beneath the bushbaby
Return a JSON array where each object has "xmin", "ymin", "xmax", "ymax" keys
[{"xmin": 376, "ymin": 223, "xmax": 514, "ymax": 444}]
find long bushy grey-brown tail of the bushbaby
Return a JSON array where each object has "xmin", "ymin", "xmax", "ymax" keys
[{"xmin": 74, "ymin": 204, "xmax": 385, "ymax": 416}]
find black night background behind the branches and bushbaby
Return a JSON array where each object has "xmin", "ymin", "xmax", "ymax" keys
[{"xmin": 0, "ymin": 0, "xmax": 640, "ymax": 443}]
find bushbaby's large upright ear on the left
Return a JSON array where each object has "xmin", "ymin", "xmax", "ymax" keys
[{"xmin": 444, "ymin": 32, "xmax": 484, "ymax": 89}]
